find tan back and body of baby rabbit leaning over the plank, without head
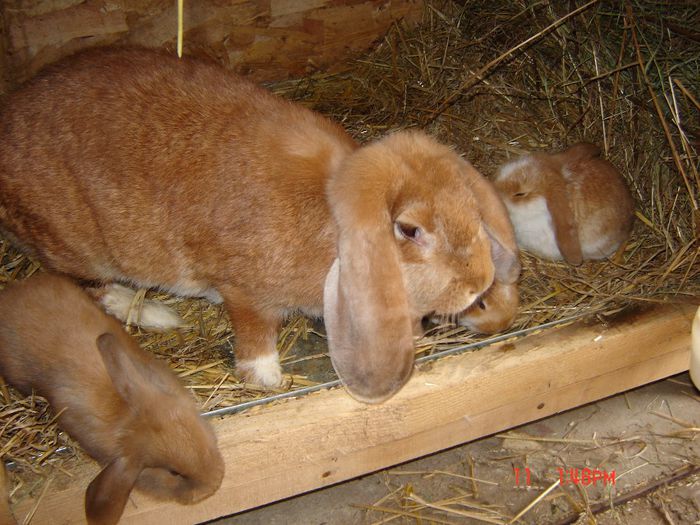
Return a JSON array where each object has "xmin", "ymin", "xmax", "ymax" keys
[{"xmin": 0, "ymin": 274, "xmax": 127, "ymax": 458}]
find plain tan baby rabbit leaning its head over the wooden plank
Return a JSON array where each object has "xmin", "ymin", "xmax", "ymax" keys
[{"xmin": 0, "ymin": 274, "xmax": 224, "ymax": 524}]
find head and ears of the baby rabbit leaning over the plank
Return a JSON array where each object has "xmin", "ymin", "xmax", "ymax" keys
[{"xmin": 85, "ymin": 333, "xmax": 224, "ymax": 523}]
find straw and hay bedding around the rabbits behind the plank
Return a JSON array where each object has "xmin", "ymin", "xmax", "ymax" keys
[{"xmin": 0, "ymin": 0, "xmax": 700, "ymax": 508}]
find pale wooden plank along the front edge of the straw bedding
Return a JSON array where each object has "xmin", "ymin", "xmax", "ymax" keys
[{"xmin": 16, "ymin": 305, "xmax": 695, "ymax": 524}]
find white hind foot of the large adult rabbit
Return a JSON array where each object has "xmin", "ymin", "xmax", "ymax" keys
[{"xmin": 100, "ymin": 283, "xmax": 185, "ymax": 330}]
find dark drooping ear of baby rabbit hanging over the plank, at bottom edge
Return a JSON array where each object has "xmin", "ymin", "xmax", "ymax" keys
[{"xmin": 85, "ymin": 457, "xmax": 141, "ymax": 525}]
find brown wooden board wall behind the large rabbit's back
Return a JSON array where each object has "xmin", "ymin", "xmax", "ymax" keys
[{"xmin": 0, "ymin": 0, "xmax": 423, "ymax": 88}]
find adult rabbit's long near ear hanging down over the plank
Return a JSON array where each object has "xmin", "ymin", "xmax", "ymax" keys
[{"xmin": 323, "ymin": 149, "xmax": 414, "ymax": 403}]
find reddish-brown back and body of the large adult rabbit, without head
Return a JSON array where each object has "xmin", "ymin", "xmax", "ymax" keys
[{"xmin": 0, "ymin": 50, "xmax": 354, "ymax": 303}]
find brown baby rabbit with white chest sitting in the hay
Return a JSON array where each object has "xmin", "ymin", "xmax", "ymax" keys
[{"xmin": 495, "ymin": 143, "xmax": 634, "ymax": 264}]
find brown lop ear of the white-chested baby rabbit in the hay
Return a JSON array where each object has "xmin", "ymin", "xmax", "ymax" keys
[{"xmin": 544, "ymin": 168, "xmax": 583, "ymax": 265}]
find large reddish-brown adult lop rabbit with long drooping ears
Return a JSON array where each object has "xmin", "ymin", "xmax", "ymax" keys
[{"xmin": 0, "ymin": 49, "xmax": 517, "ymax": 402}]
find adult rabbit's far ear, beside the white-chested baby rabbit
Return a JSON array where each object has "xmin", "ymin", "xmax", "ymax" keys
[{"xmin": 461, "ymin": 159, "xmax": 520, "ymax": 284}]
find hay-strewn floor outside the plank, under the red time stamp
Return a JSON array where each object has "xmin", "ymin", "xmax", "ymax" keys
[{"xmin": 356, "ymin": 380, "xmax": 700, "ymax": 525}]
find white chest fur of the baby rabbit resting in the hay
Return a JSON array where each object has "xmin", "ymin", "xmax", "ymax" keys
[{"xmin": 506, "ymin": 197, "xmax": 562, "ymax": 260}]
